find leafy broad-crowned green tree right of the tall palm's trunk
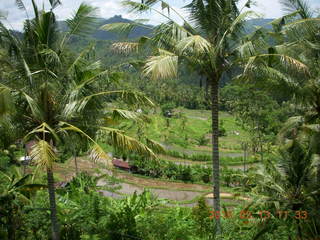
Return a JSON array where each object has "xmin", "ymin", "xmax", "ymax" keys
[{"xmin": 221, "ymin": 84, "xmax": 292, "ymax": 156}]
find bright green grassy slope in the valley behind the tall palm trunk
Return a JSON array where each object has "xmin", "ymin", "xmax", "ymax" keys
[{"xmin": 121, "ymin": 109, "xmax": 248, "ymax": 154}]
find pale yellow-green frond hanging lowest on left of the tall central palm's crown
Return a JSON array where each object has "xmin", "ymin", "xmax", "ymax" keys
[{"xmin": 143, "ymin": 49, "xmax": 178, "ymax": 79}]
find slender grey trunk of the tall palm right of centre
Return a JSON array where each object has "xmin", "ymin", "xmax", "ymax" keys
[{"xmin": 211, "ymin": 79, "xmax": 221, "ymax": 235}]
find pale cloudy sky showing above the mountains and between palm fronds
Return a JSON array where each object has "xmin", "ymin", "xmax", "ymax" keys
[{"xmin": 0, "ymin": 0, "xmax": 320, "ymax": 30}]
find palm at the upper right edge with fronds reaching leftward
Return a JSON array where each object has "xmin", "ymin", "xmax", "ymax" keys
[{"xmin": 242, "ymin": 0, "xmax": 320, "ymax": 183}]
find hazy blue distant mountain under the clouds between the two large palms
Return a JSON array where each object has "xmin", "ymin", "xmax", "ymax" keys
[{"xmin": 59, "ymin": 15, "xmax": 151, "ymax": 41}]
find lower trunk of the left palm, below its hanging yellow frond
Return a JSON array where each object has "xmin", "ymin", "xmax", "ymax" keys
[{"xmin": 47, "ymin": 168, "xmax": 60, "ymax": 240}]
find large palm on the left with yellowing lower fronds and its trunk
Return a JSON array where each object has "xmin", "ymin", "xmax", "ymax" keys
[{"xmin": 0, "ymin": 0, "xmax": 162, "ymax": 240}]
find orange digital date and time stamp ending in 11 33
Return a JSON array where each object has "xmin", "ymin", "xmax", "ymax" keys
[{"xmin": 209, "ymin": 210, "xmax": 308, "ymax": 220}]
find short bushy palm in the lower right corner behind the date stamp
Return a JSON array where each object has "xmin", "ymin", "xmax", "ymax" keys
[{"xmin": 253, "ymin": 134, "xmax": 319, "ymax": 239}]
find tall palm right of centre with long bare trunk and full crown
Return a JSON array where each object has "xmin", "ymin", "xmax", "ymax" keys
[{"xmin": 102, "ymin": 0, "xmax": 258, "ymax": 233}]
